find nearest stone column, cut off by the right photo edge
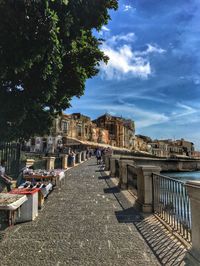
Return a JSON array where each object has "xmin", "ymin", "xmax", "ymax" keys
[{"xmin": 185, "ymin": 181, "xmax": 200, "ymax": 266}]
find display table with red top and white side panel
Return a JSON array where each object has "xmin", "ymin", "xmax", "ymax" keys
[{"xmin": 9, "ymin": 188, "xmax": 40, "ymax": 222}]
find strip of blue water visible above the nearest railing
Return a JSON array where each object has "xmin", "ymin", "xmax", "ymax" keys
[{"xmin": 162, "ymin": 171, "xmax": 200, "ymax": 182}]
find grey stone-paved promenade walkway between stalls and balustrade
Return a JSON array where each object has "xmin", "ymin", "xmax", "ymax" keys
[{"xmin": 0, "ymin": 159, "xmax": 182, "ymax": 266}]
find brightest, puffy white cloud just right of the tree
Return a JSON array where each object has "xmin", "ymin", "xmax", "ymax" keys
[{"xmin": 101, "ymin": 44, "xmax": 151, "ymax": 79}]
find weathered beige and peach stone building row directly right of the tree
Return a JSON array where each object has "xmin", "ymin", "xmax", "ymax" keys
[{"xmin": 26, "ymin": 113, "xmax": 110, "ymax": 153}]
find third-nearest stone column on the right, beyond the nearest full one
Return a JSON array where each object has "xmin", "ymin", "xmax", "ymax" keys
[{"xmin": 119, "ymin": 160, "xmax": 133, "ymax": 189}]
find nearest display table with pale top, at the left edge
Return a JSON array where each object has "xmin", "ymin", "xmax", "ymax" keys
[{"xmin": 0, "ymin": 193, "xmax": 28, "ymax": 226}]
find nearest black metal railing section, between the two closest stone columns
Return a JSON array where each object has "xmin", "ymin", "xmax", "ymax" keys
[{"xmin": 153, "ymin": 174, "xmax": 191, "ymax": 243}]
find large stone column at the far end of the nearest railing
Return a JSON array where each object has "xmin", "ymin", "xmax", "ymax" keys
[{"xmin": 136, "ymin": 165, "xmax": 161, "ymax": 213}]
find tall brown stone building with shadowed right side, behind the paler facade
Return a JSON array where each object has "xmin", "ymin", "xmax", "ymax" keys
[{"xmin": 93, "ymin": 114, "xmax": 135, "ymax": 149}]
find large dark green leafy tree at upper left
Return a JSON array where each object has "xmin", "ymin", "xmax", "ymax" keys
[{"xmin": 0, "ymin": 0, "xmax": 117, "ymax": 140}]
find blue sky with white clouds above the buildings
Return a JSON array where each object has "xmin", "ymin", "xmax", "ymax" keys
[{"xmin": 66, "ymin": 0, "xmax": 200, "ymax": 149}]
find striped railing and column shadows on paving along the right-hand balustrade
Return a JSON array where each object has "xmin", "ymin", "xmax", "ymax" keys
[{"xmin": 102, "ymin": 170, "xmax": 186, "ymax": 266}]
